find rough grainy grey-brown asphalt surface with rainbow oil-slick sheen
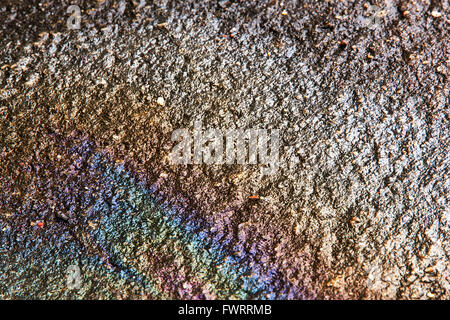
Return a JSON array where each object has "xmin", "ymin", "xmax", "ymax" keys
[{"xmin": 0, "ymin": 0, "xmax": 450, "ymax": 299}]
